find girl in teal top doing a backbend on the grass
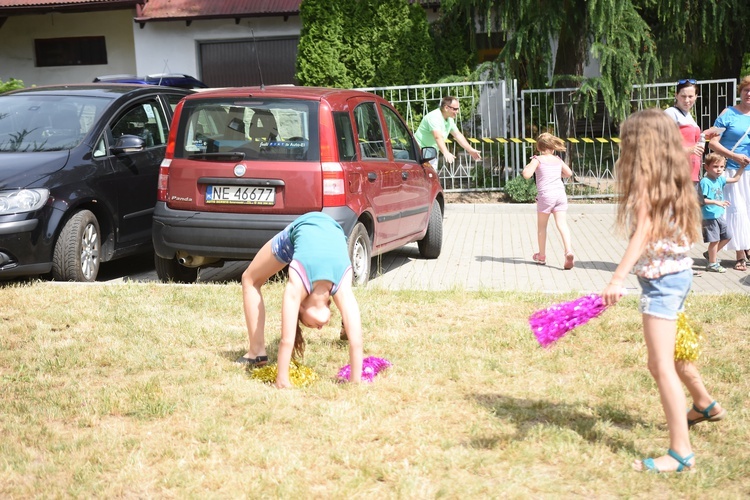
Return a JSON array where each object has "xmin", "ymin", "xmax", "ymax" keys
[{"xmin": 237, "ymin": 212, "xmax": 363, "ymax": 388}]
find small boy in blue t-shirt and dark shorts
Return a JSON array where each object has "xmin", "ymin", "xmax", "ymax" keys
[{"xmin": 700, "ymin": 153, "xmax": 745, "ymax": 273}]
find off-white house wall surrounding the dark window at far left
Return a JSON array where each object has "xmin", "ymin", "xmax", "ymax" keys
[{"xmin": 0, "ymin": 9, "xmax": 136, "ymax": 87}]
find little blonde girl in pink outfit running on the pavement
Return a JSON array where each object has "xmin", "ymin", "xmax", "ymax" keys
[{"xmin": 521, "ymin": 132, "xmax": 575, "ymax": 269}]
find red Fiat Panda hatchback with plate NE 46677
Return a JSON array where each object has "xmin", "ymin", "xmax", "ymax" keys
[{"xmin": 153, "ymin": 86, "xmax": 444, "ymax": 285}]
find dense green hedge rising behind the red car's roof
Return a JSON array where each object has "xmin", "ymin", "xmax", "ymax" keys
[{"xmin": 296, "ymin": 0, "xmax": 475, "ymax": 88}]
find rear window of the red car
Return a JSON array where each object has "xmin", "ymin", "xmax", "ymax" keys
[{"xmin": 175, "ymin": 99, "xmax": 320, "ymax": 161}]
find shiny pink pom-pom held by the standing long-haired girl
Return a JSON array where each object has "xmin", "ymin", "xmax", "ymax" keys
[{"xmin": 529, "ymin": 293, "xmax": 607, "ymax": 347}]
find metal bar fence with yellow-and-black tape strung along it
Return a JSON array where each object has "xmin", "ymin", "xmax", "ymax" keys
[{"xmin": 361, "ymin": 79, "xmax": 737, "ymax": 198}]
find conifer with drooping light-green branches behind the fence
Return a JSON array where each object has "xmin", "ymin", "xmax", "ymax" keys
[{"xmin": 443, "ymin": 0, "xmax": 659, "ymax": 122}]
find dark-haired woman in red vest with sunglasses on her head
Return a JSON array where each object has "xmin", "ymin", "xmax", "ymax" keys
[{"xmin": 664, "ymin": 78, "xmax": 706, "ymax": 184}]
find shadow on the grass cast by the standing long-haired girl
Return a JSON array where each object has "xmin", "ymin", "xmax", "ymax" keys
[{"xmin": 471, "ymin": 394, "xmax": 650, "ymax": 454}]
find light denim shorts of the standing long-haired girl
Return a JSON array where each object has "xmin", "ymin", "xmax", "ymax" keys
[{"xmin": 638, "ymin": 269, "xmax": 693, "ymax": 320}]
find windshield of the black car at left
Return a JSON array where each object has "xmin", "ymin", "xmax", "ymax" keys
[{"xmin": 0, "ymin": 94, "xmax": 112, "ymax": 152}]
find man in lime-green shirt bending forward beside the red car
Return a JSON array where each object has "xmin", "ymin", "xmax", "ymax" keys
[{"xmin": 414, "ymin": 96, "xmax": 482, "ymax": 168}]
